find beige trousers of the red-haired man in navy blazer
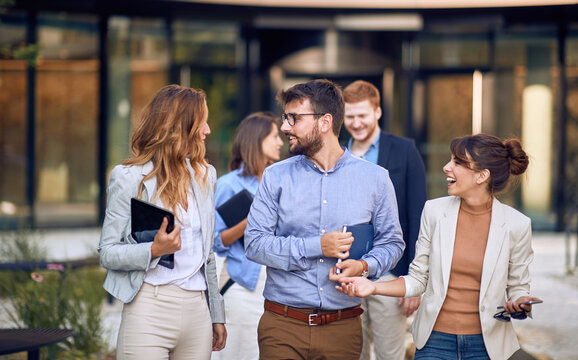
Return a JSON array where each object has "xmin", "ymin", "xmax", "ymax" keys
[{"xmin": 360, "ymin": 274, "xmax": 407, "ymax": 360}]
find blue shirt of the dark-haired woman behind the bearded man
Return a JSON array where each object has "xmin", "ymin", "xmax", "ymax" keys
[{"xmin": 213, "ymin": 169, "xmax": 262, "ymax": 290}]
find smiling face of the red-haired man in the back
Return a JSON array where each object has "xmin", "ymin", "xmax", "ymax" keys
[{"xmin": 344, "ymin": 100, "xmax": 381, "ymax": 142}]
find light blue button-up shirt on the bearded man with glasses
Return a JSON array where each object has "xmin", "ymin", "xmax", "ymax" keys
[{"xmin": 245, "ymin": 150, "xmax": 405, "ymax": 310}]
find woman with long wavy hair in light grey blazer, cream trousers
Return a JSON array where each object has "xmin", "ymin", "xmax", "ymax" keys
[{"xmin": 98, "ymin": 85, "xmax": 227, "ymax": 360}]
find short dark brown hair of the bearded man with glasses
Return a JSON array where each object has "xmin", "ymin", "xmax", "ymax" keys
[{"xmin": 277, "ymin": 79, "xmax": 345, "ymax": 136}]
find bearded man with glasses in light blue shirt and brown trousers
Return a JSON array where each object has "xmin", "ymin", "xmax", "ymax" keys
[{"xmin": 245, "ymin": 80, "xmax": 405, "ymax": 360}]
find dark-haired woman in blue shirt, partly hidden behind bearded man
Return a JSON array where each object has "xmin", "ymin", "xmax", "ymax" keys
[{"xmin": 215, "ymin": 112, "xmax": 283, "ymax": 360}]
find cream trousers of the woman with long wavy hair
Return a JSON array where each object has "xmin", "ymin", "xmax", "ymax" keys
[{"xmin": 116, "ymin": 283, "xmax": 213, "ymax": 360}]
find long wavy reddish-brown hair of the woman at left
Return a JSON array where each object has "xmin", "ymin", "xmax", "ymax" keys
[{"xmin": 124, "ymin": 85, "xmax": 209, "ymax": 211}]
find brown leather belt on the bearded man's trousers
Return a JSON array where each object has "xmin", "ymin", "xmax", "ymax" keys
[{"xmin": 265, "ymin": 300, "xmax": 363, "ymax": 326}]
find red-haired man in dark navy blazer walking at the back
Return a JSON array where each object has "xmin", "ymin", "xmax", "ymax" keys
[{"xmin": 343, "ymin": 80, "xmax": 426, "ymax": 360}]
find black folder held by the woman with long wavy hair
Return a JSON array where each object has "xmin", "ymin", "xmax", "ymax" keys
[{"xmin": 130, "ymin": 198, "xmax": 175, "ymax": 269}]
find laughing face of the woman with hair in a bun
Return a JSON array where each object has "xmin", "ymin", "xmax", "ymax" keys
[{"xmin": 443, "ymin": 155, "xmax": 486, "ymax": 198}]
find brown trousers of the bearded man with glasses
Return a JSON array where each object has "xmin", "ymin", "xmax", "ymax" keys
[{"xmin": 257, "ymin": 304, "xmax": 363, "ymax": 360}]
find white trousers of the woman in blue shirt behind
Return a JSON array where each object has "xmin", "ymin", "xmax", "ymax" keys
[{"xmin": 212, "ymin": 266, "xmax": 267, "ymax": 360}]
